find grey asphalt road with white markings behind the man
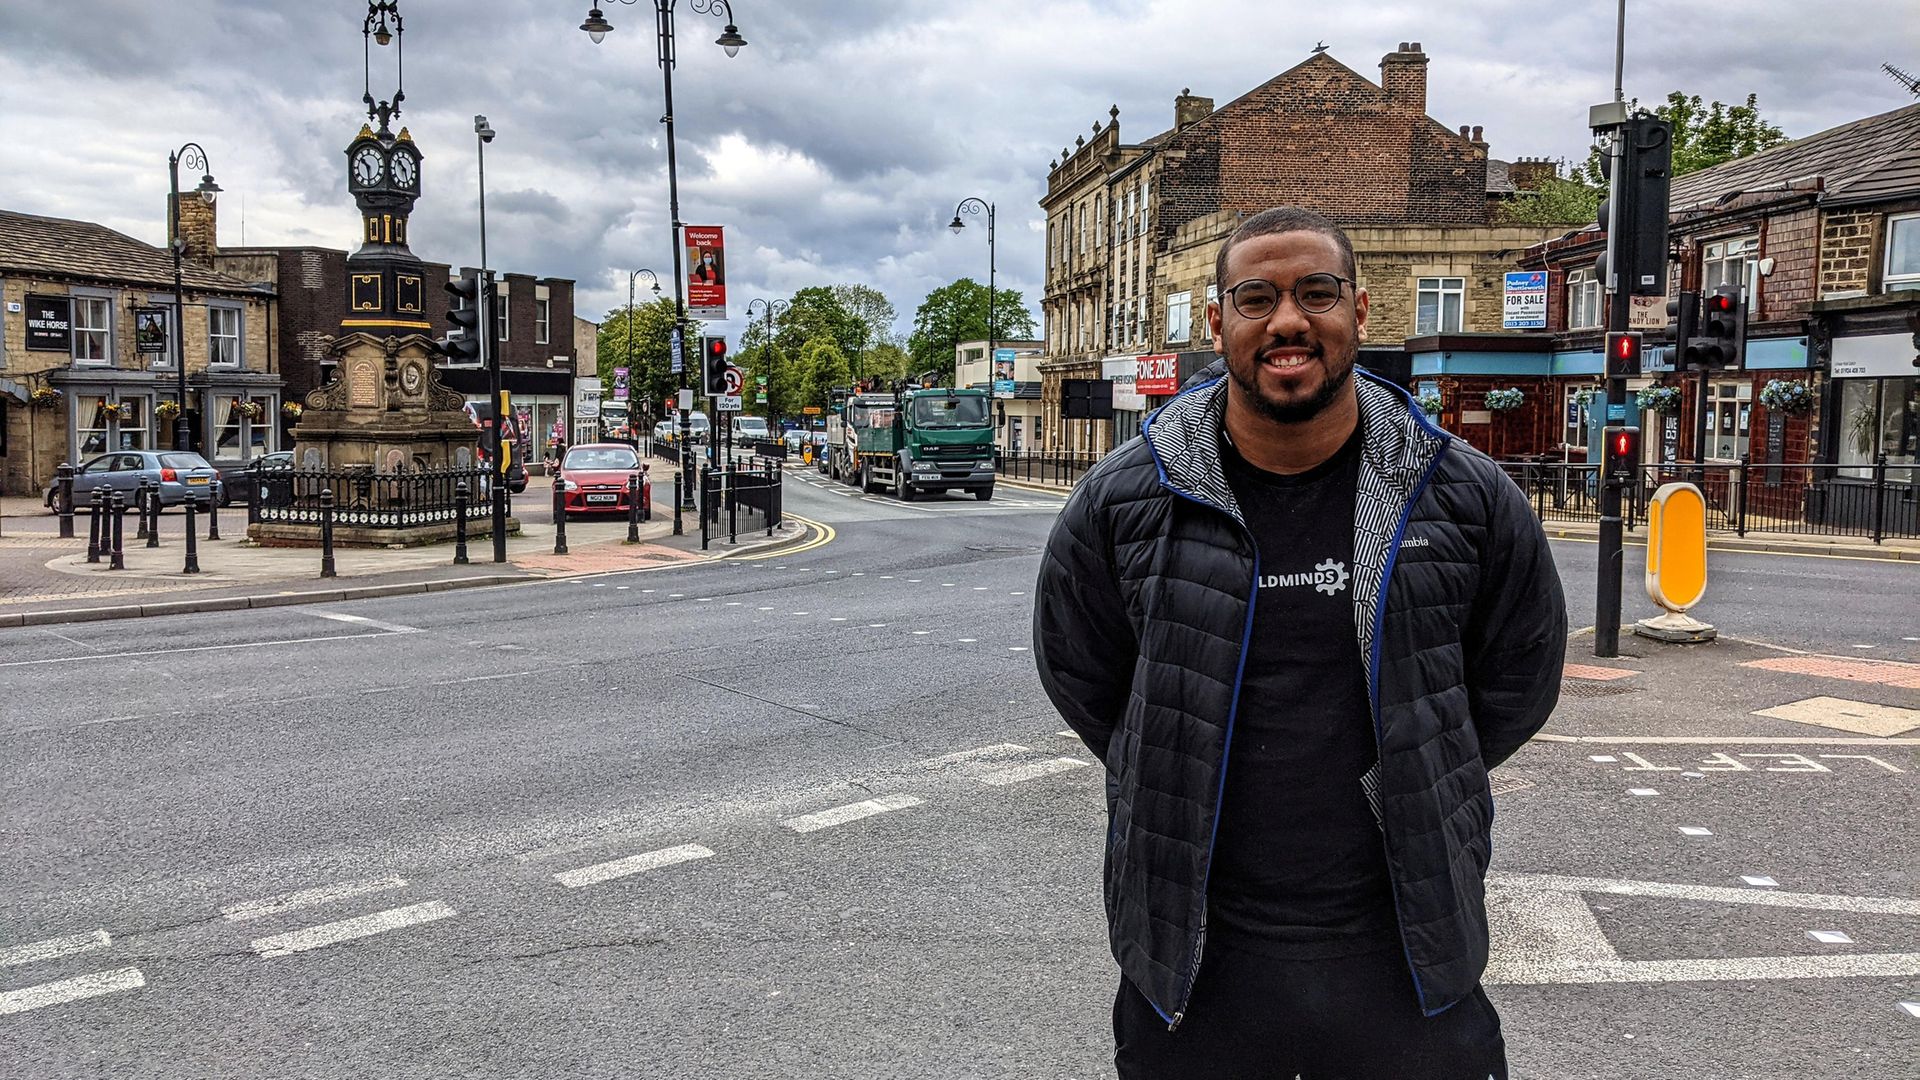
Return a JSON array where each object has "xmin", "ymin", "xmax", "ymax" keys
[{"xmin": 0, "ymin": 473, "xmax": 1920, "ymax": 1080}]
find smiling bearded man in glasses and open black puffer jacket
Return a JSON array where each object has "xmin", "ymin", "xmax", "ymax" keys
[{"xmin": 1033, "ymin": 208, "xmax": 1567, "ymax": 1080}]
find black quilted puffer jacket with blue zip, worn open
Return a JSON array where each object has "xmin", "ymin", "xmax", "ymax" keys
[{"xmin": 1033, "ymin": 371, "xmax": 1567, "ymax": 1024}]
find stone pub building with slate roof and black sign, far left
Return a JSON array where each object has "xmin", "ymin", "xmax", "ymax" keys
[{"xmin": 0, "ymin": 206, "xmax": 290, "ymax": 494}]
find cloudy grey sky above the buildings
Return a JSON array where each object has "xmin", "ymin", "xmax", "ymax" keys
[{"xmin": 0, "ymin": 0, "xmax": 1920, "ymax": 331}]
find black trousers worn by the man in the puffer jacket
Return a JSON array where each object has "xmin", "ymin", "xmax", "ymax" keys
[{"xmin": 1114, "ymin": 942, "xmax": 1507, "ymax": 1080}]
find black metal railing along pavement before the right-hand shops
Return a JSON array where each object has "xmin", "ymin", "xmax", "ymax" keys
[{"xmin": 1500, "ymin": 455, "xmax": 1920, "ymax": 544}]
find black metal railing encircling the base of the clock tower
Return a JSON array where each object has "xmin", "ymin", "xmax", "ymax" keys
[{"xmin": 242, "ymin": 469, "xmax": 490, "ymax": 528}]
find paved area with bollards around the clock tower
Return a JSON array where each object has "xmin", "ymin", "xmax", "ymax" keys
[{"xmin": 0, "ymin": 469, "xmax": 806, "ymax": 626}]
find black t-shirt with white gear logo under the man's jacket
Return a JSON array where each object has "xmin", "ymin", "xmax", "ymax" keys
[{"xmin": 1208, "ymin": 430, "xmax": 1396, "ymax": 959}]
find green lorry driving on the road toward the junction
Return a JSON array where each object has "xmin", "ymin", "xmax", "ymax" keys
[{"xmin": 828, "ymin": 388, "xmax": 995, "ymax": 502}]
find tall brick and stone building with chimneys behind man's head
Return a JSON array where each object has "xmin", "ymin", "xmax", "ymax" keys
[{"xmin": 1041, "ymin": 42, "xmax": 1559, "ymax": 452}]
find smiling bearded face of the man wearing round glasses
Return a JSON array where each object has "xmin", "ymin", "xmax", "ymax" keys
[{"xmin": 1206, "ymin": 233, "xmax": 1367, "ymax": 423}]
